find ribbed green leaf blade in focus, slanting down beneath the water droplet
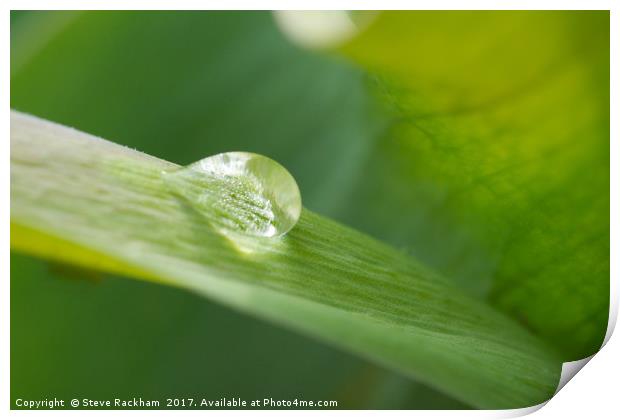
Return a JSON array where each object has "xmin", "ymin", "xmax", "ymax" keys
[{"xmin": 11, "ymin": 113, "xmax": 560, "ymax": 408}]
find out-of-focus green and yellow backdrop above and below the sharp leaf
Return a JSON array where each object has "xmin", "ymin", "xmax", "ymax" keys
[{"xmin": 11, "ymin": 12, "xmax": 609, "ymax": 408}]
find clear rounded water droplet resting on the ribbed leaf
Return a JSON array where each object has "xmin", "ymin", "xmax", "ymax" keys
[{"xmin": 164, "ymin": 152, "xmax": 301, "ymax": 237}]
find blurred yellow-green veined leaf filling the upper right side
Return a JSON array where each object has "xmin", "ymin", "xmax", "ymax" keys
[{"xmin": 334, "ymin": 11, "xmax": 609, "ymax": 360}]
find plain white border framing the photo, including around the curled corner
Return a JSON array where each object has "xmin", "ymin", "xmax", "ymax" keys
[{"xmin": 0, "ymin": 0, "xmax": 620, "ymax": 419}]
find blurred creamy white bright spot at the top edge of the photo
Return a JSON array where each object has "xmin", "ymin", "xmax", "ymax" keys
[{"xmin": 273, "ymin": 10, "xmax": 358, "ymax": 48}]
